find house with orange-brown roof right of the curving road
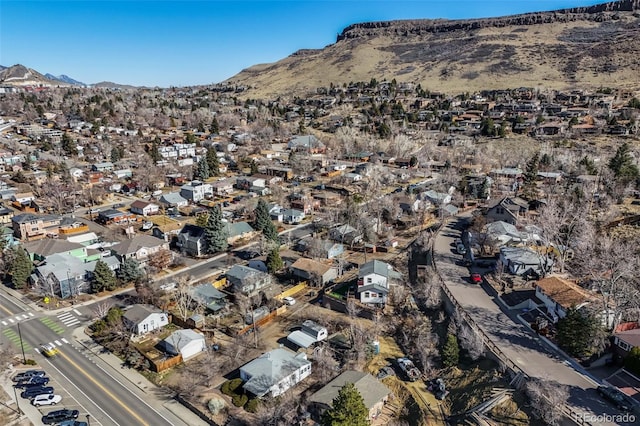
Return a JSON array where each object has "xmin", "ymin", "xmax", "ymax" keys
[{"xmin": 536, "ymin": 276, "xmax": 596, "ymax": 321}]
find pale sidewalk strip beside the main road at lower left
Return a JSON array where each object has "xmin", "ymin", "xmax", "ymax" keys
[{"xmin": 72, "ymin": 327, "xmax": 207, "ymax": 426}]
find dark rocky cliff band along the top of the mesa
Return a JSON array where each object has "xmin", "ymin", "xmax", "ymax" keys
[{"xmin": 337, "ymin": 0, "xmax": 640, "ymax": 41}]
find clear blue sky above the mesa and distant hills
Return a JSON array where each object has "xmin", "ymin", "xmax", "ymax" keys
[{"xmin": 0, "ymin": 0, "xmax": 600, "ymax": 87}]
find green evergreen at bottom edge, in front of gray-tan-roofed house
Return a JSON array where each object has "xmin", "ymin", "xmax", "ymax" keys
[{"xmin": 322, "ymin": 383, "xmax": 369, "ymax": 426}]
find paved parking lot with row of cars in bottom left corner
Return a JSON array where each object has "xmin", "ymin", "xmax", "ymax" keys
[{"xmin": 5, "ymin": 368, "xmax": 94, "ymax": 425}]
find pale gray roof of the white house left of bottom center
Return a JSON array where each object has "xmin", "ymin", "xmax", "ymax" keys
[{"xmin": 240, "ymin": 348, "xmax": 311, "ymax": 396}]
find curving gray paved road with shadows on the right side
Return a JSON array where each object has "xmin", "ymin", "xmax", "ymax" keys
[{"xmin": 434, "ymin": 219, "xmax": 631, "ymax": 425}]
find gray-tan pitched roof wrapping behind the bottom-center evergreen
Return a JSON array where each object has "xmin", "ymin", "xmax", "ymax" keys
[{"xmin": 309, "ymin": 370, "xmax": 391, "ymax": 410}]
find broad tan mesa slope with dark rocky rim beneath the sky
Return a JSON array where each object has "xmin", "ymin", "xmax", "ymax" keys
[{"xmin": 226, "ymin": 0, "xmax": 640, "ymax": 97}]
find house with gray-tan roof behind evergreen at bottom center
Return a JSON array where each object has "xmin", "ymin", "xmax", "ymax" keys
[{"xmin": 309, "ymin": 370, "xmax": 391, "ymax": 421}]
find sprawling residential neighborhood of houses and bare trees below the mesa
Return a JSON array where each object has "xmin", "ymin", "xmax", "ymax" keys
[{"xmin": 0, "ymin": 67, "xmax": 640, "ymax": 425}]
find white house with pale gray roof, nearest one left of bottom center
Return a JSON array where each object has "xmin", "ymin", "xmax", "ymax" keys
[{"xmin": 240, "ymin": 348, "xmax": 311, "ymax": 398}]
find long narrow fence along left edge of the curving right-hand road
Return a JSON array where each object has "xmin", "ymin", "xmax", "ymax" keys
[{"xmin": 431, "ymin": 223, "xmax": 591, "ymax": 426}]
